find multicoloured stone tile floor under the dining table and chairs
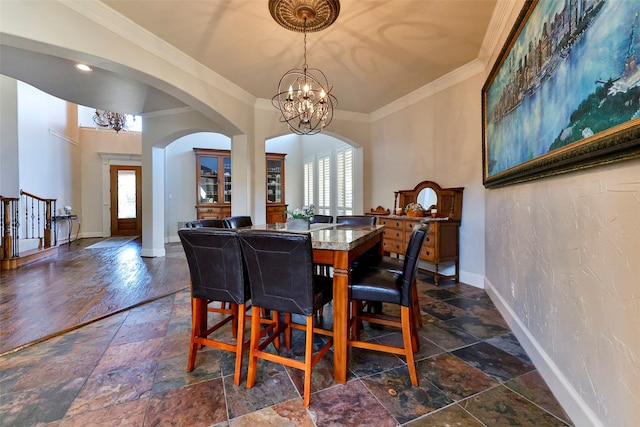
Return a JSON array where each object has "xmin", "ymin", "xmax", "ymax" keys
[{"xmin": 0, "ymin": 275, "xmax": 571, "ymax": 427}]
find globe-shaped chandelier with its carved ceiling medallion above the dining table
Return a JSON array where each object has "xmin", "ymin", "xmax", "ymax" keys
[{"xmin": 269, "ymin": 0, "xmax": 340, "ymax": 135}]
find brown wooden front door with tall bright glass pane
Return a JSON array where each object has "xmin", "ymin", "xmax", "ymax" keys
[{"xmin": 111, "ymin": 166, "xmax": 142, "ymax": 236}]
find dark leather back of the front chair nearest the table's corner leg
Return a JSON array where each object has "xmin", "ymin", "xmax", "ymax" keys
[{"xmin": 238, "ymin": 230, "xmax": 314, "ymax": 316}]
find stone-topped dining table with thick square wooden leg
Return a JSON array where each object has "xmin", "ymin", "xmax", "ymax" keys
[{"xmin": 250, "ymin": 223, "xmax": 384, "ymax": 384}]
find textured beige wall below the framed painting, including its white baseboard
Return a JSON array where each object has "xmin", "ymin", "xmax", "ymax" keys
[{"xmin": 486, "ymin": 160, "xmax": 640, "ymax": 426}]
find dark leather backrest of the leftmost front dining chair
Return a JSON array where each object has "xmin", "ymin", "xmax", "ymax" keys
[{"xmin": 178, "ymin": 227, "xmax": 250, "ymax": 304}]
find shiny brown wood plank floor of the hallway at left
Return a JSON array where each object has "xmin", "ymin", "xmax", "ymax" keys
[{"xmin": 0, "ymin": 239, "xmax": 189, "ymax": 355}]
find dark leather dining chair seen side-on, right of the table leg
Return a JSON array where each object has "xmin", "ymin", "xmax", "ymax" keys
[{"xmin": 347, "ymin": 224, "xmax": 429, "ymax": 386}]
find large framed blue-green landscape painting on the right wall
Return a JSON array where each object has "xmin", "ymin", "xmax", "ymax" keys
[{"xmin": 482, "ymin": 0, "xmax": 640, "ymax": 188}]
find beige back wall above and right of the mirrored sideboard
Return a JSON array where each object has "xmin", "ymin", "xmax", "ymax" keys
[{"xmin": 365, "ymin": 74, "xmax": 485, "ymax": 287}]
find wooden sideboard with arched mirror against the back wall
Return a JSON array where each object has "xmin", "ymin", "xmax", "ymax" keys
[{"xmin": 378, "ymin": 181, "xmax": 464, "ymax": 285}]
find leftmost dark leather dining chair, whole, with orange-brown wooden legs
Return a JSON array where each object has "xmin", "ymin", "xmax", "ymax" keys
[{"xmin": 178, "ymin": 227, "xmax": 251, "ymax": 385}]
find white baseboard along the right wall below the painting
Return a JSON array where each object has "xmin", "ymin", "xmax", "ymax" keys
[{"xmin": 484, "ymin": 278, "xmax": 605, "ymax": 427}]
